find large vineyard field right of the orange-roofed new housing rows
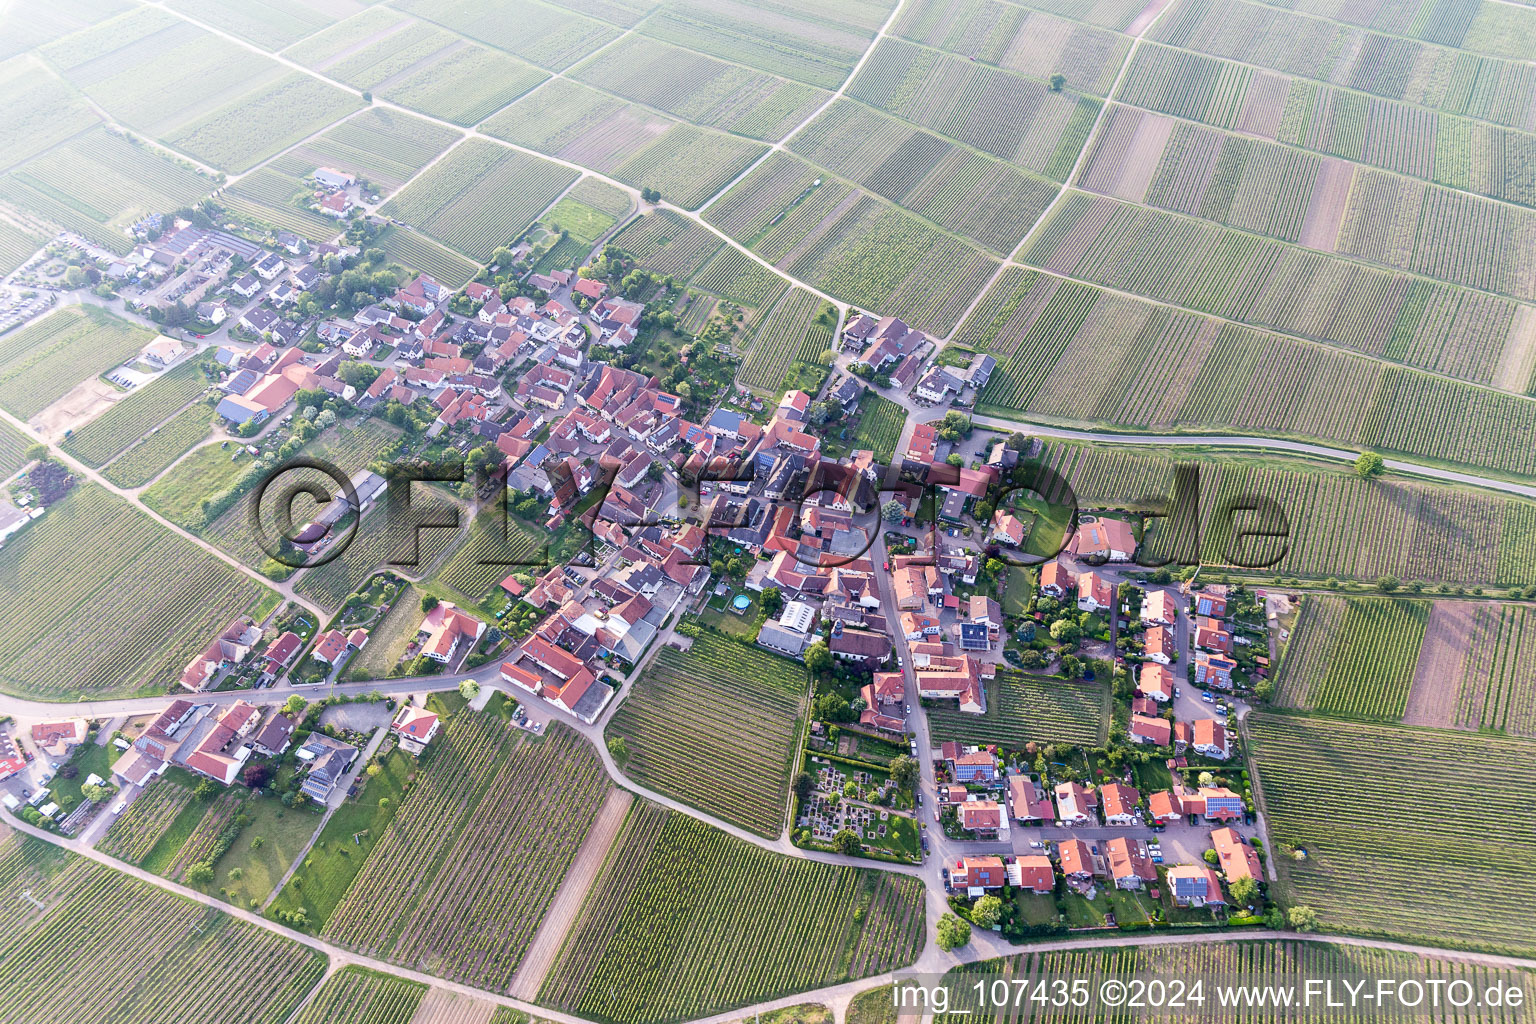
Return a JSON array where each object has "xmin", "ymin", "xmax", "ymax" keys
[{"xmin": 1246, "ymin": 712, "xmax": 1536, "ymax": 955}]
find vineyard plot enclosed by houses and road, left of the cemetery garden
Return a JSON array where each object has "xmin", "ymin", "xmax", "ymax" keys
[{"xmin": 607, "ymin": 629, "xmax": 806, "ymax": 837}]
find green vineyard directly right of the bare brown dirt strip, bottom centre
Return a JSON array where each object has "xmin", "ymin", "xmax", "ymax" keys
[{"xmin": 539, "ymin": 801, "xmax": 925, "ymax": 1024}]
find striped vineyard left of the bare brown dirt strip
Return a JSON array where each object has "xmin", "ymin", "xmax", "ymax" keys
[{"xmin": 321, "ymin": 708, "xmax": 608, "ymax": 992}]
